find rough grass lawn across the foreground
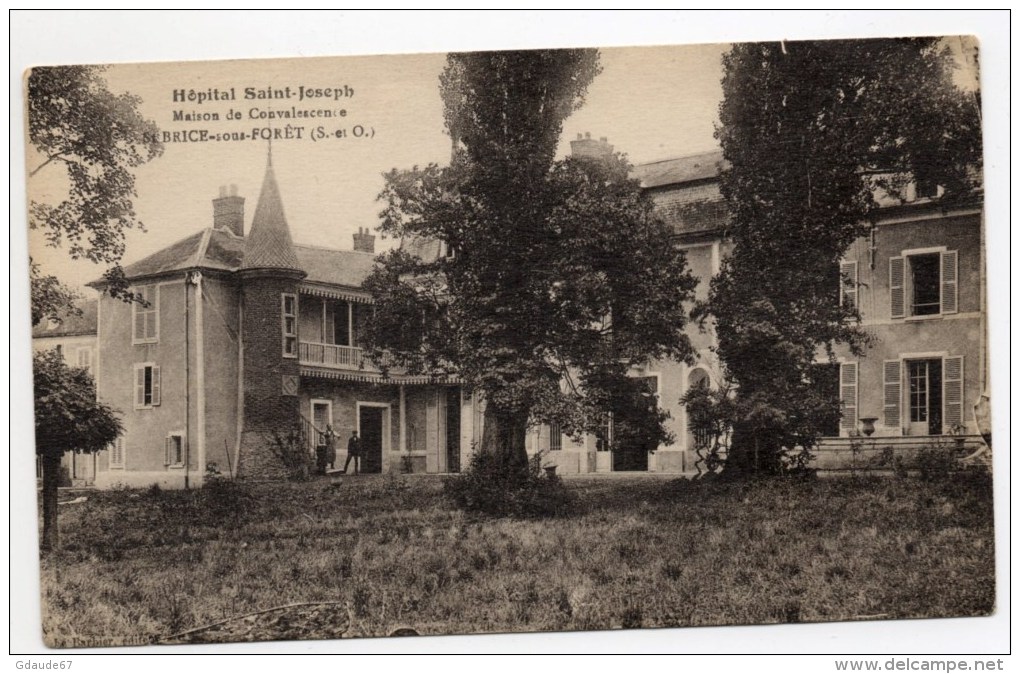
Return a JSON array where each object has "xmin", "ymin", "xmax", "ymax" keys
[{"xmin": 35, "ymin": 475, "xmax": 995, "ymax": 645}]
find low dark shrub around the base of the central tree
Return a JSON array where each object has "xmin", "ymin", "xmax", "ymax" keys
[{"xmin": 443, "ymin": 452, "xmax": 575, "ymax": 517}]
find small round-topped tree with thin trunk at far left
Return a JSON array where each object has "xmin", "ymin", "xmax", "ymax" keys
[{"xmin": 33, "ymin": 350, "xmax": 122, "ymax": 550}]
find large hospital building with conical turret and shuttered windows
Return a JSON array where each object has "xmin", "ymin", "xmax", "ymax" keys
[{"xmin": 93, "ymin": 138, "xmax": 986, "ymax": 486}]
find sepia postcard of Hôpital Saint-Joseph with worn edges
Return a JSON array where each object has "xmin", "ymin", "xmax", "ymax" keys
[{"xmin": 11, "ymin": 10, "xmax": 1009, "ymax": 665}]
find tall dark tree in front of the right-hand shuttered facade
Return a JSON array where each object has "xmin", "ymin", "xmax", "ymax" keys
[{"xmin": 708, "ymin": 38, "xmax": 980, "ymax": 474}]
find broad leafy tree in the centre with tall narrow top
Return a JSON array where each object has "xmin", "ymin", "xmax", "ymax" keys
[{"xmin": 365, "ymin": 50, "xmax": 695, "ymax": 467}]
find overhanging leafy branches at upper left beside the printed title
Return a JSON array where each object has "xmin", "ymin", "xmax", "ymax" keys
[{"xmin": 28, "ymin": 65, "xmax": 163, "ymax": 324}]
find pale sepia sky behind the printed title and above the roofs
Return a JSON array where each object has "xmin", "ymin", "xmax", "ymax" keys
[{"xmin": 29, "ymin": 45, "xmax": 726, "ymax": 286}]
